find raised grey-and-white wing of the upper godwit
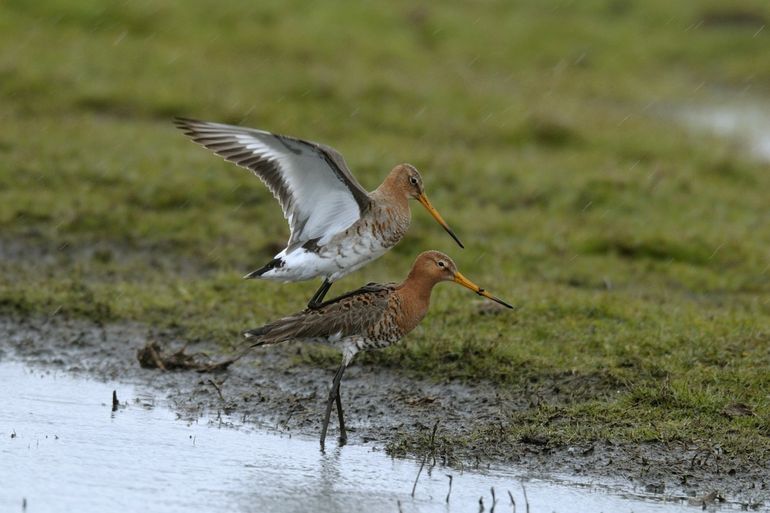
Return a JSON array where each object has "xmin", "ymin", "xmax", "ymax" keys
[{"xmin": 176, "ymin": 118, "xmax": 370, "ymax": 248}]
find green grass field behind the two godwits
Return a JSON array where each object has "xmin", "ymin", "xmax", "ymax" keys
[{"xmin": 0, "ymin": 0, "xmax": 770, "ymax": 454}]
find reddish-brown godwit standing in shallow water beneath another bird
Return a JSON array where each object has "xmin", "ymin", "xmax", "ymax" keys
[{"xmin": 244, "ymin": 251, "xmax": 513, "ymax": 448}]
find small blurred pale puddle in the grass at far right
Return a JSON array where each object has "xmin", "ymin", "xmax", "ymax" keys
[{"xmin": 684, "ymin": 102, "xmax": 770, "ymax": 162}]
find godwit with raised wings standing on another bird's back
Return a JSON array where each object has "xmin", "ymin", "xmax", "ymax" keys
[{"xmin": 176, "ymin": 118, "xmax": 463, "ymax": 308}]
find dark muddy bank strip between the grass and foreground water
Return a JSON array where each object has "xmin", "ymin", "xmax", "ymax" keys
[{"xmin": 0, "ymin": 316, "xmax": 770, "ymax": 509}]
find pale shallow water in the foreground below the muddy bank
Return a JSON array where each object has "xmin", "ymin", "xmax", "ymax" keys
[{"xmin": 0, "ymin": 362, "xmax": 712, "ymax": 513}]
